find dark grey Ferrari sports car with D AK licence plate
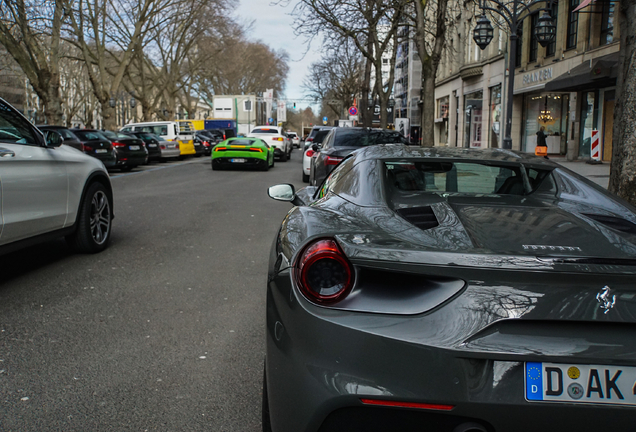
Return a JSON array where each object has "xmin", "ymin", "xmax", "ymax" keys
[{"xmin": 262, "ymin": 145, "xmax": 636, "ymax": 432}]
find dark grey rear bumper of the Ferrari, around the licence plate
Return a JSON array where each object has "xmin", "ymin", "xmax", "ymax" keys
[{"xmin": 266, "ymin": 272, "xmax": 634, "ymax": 432}]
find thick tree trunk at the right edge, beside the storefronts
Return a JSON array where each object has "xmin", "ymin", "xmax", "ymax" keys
[{"xmin": 609, "ymin": 0, "xmax": 636, "ymax": 205}]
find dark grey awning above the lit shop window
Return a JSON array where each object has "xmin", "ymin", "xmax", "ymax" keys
[{"xmin": 544, "ymin": 52, "xmax": 618, "ymax": 91}]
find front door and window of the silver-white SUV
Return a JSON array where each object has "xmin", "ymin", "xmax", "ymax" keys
[{"xmin": 0, "ymin": 102, "xmax": 68, "ymax": 244}]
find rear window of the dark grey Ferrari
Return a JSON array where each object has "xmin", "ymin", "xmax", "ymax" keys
[{"xmin": 384, "ymin": 161, "xmax": 525, "ymax": 195}]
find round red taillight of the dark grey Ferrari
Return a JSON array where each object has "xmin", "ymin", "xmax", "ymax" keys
[{"xmin": 296, "ymin": 239, "xmax": 354, "ymax": 304}]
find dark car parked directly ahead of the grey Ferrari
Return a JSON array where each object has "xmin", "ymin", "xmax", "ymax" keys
[{"xmin": 309, "ymin": 127, "xmax": 408, "ymax": 186}]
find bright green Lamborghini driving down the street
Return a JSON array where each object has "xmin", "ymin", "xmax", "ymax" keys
[{"xmin": 212, "ymin": 138, "xmax": 274, "ymax": 171}]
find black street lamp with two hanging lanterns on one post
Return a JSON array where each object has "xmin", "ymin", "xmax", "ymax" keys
[{"xmin": 473, "ymin": 0, "xmax": 556, "ymax": 149}]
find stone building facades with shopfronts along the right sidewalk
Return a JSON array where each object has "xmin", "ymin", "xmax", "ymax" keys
[{"xmin": 420, "ymin": 0, "xmax": 620, "ymax": 160}]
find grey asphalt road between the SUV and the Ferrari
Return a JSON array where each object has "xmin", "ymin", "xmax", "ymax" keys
[{"xmin": 0, "ymin": 150, "xmax": 302, "ymax": 432}]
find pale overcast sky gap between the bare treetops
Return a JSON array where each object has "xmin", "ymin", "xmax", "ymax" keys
[{"xmin": 235, "ymin": 0, "xmax": 320, "ymax": 108}]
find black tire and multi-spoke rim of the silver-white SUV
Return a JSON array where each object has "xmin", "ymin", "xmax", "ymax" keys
[{"xmin": 66, "ymin": 182, "xmax": 113, "ymax": 253}]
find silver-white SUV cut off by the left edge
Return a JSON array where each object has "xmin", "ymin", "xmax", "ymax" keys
[{"xmin": 0, "ymin": 99, "xmax": 114, "ymax": 254}]
